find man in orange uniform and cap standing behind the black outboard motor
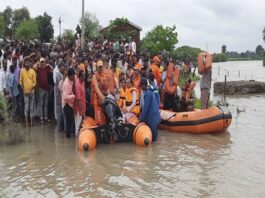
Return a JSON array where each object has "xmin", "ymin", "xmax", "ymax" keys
[{"xmin": 91, "ymin": 60, "xmax": 108, "ymax": 125}]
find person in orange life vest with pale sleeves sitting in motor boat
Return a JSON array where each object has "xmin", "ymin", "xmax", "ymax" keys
[{"xmin": 122, "ymin": 78, "xmax": 140, "ymax": 121}]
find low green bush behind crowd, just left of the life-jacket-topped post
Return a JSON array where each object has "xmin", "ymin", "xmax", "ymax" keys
[{"xmin": 171, "ymin": 46, "xmax": 202, "ymax": 62}]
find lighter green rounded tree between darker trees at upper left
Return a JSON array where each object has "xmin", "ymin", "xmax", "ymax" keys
[{"xmin": 15, "ymin": 19, "xmax": 40, "ymax": 41}]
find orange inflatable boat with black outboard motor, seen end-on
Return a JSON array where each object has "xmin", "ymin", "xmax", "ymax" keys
[{"xmin": 77, "ymin": 97, "xmax": 152, "ymax": 151}]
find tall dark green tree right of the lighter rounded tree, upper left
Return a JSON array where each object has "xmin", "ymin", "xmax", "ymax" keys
[{"xmin": 35, "ymin": 12, "xmax": 54, "ymax": 42}]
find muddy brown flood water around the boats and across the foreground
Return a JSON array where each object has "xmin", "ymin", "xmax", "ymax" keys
[{"xmin": 0, "ymin": 61, "xmax": 265, "ymax": 197}]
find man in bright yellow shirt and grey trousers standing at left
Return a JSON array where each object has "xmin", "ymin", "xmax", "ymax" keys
[{"xmin": 19, "ymin": 60, "xmax": 36, "ymax": 125}]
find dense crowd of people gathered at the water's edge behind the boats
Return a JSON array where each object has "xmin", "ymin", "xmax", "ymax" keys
[{"xmin": 0, "ymin": 39, "xmax": 210, "ymax": 141}]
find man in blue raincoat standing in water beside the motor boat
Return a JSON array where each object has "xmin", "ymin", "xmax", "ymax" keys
[{"xmin": 139, "ymin": 78, "xmax": 161, "ymax": 141}]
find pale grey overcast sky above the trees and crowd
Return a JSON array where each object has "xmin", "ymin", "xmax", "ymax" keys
[{"xmin": 0, "ymin": 0, "xmax": 265, "ymax": 52}]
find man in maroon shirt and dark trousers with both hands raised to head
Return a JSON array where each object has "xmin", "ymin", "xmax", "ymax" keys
[{"xmin": 34, "ymin": 58, "xmax": 53, "ymax": 124}]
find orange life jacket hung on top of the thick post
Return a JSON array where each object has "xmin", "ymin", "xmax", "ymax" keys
[{"xmin": 197, "ymin": 52, "xmax": 213, "ymax": 75}]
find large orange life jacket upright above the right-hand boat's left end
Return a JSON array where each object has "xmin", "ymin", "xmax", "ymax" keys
[{"xmin": 165, "ymin": 63, "xmax": 179, "ymax": 95}]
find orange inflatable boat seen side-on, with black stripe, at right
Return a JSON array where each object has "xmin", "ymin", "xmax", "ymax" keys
[{"xmin": 159, "ymin": 106, "xmax": 232, "ymax": 134}]
